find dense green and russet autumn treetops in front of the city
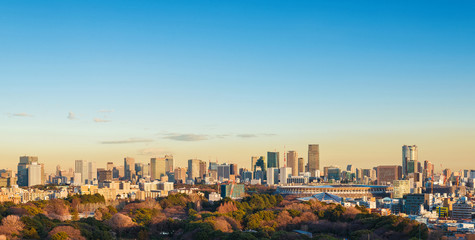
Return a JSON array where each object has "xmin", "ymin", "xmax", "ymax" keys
[{"xmin": 0, "ymin": 194, "xmax": 436, "ymax": 240}]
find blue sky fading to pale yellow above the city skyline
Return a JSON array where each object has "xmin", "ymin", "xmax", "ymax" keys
[{"xmin": 0, "ymin": 0, "xmax": 475, "ymax": 171}]
